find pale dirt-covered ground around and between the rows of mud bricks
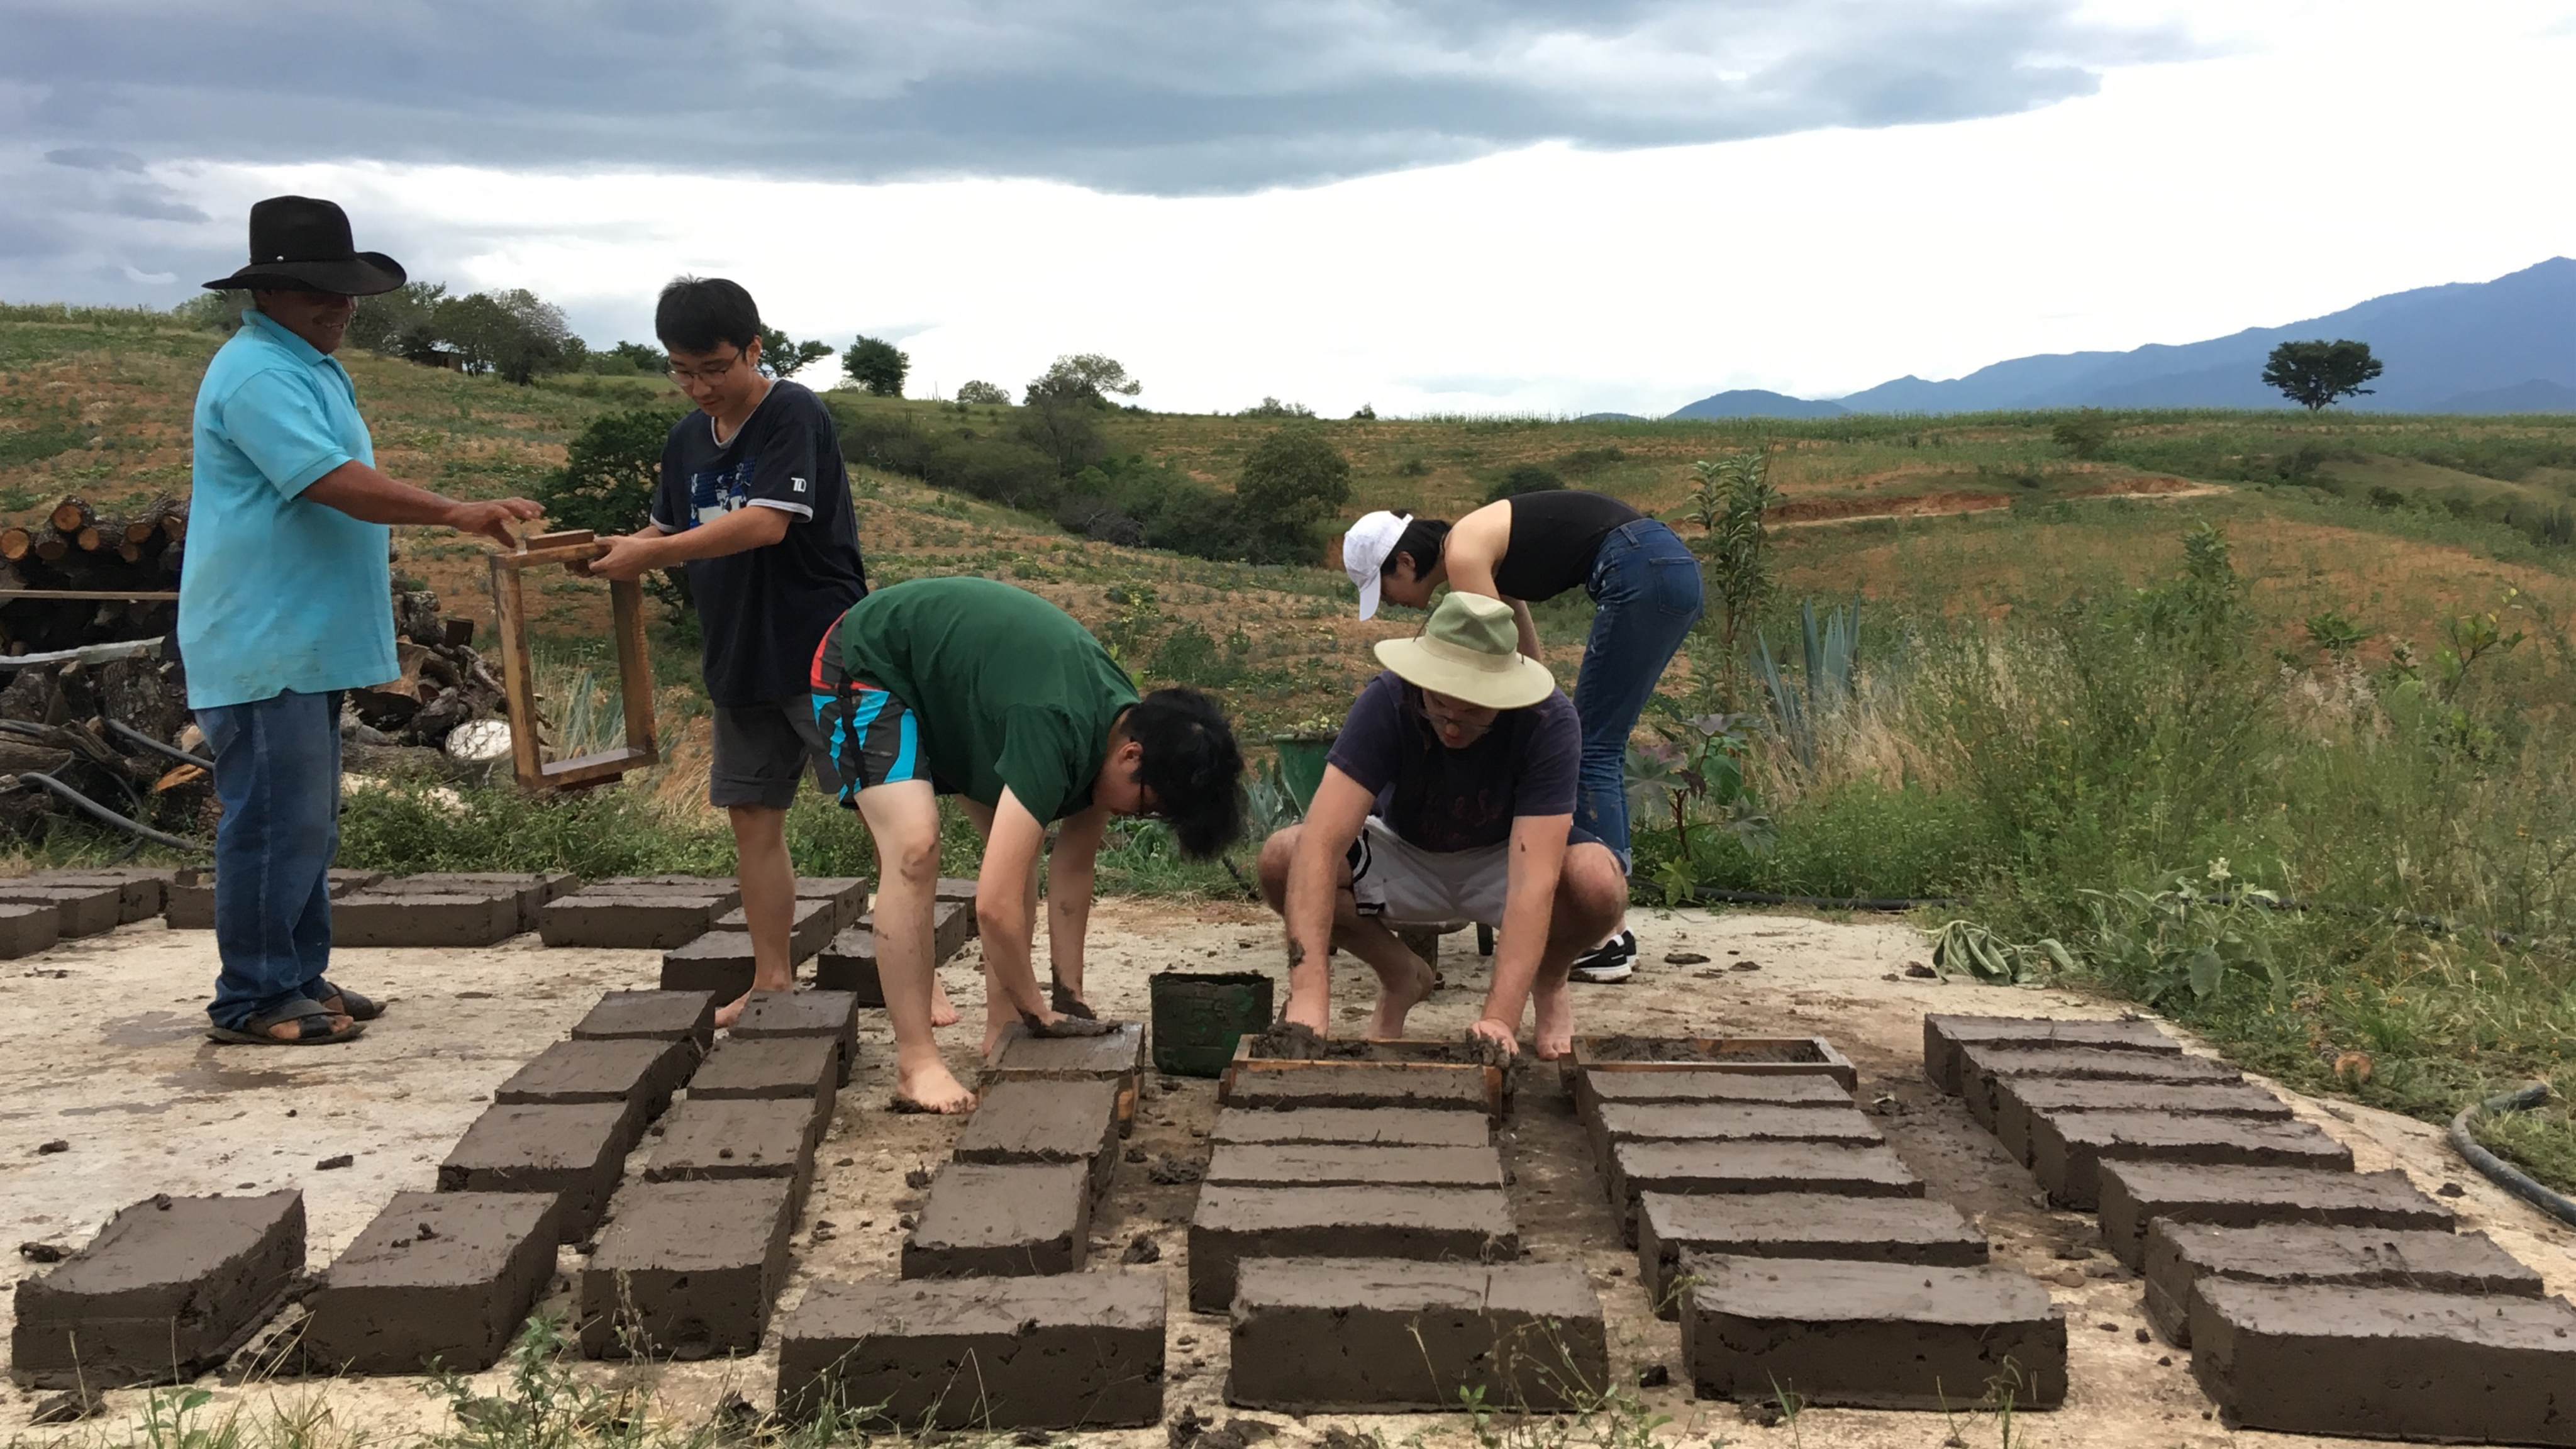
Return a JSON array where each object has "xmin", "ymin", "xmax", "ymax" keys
[{"xmin": 0, "ymin": 900, "xmax": 2576, "ymax": 1449}]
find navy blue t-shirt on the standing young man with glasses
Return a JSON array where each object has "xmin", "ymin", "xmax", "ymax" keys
[{"xmin": 652, "ymin": 382, "xmax": 868, "ymax": 709}]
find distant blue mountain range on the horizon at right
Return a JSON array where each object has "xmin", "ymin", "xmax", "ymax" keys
[{"xmin": 1674, "ymin": 258, "xmax": 2576, "ymax": 418}]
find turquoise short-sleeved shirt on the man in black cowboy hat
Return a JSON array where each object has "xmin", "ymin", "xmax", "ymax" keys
[{"xmin": 178, "ymin": 312, "xmax": 402, "ymax": 709}]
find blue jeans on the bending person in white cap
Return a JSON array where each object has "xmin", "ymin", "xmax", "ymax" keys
[{"xmin": 1574, "ymin": 518, "xmax": 1700, "ymax": 872}]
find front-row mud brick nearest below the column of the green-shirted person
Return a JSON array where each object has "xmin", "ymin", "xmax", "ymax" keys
[{"xmin": 778, "ymin": 1269, "xmax": 1164, "ymax": 1431}]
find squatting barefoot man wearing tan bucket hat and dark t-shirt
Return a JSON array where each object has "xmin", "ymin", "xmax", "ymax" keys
[{"xmin": 1260, "ymin": 593, "xmax": 1628, "ymax": 1060}]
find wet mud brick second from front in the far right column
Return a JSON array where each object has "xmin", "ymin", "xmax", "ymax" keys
[{"xmin": 2146, "ymin": 1219, "xmax": 2543, "ymax": 1348}]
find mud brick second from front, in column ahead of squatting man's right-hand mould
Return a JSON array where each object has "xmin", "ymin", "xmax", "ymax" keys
[{"xmin": 1636, "ymin": 1191, "xmax": 1989, "ymax": 1318}]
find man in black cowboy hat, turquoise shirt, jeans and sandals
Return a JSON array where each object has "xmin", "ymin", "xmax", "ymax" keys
[{"xmin": 178, "ymin": 196, "xmax": 541, "ymax": 1046}]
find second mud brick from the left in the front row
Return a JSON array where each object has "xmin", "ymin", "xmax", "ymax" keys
[{"xmin": 304, "ymin": 1191, "xmax": 554, "ymax": 1374}]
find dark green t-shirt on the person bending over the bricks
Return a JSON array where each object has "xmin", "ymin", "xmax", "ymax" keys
[{"xmin": 840, "ymin": 577, "xmax": 1136, "ymax": 820}]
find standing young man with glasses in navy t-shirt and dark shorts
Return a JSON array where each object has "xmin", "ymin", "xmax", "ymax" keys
[{"xmin": 587, "ymin": 276, "xmax": 870, "ymax": 1026}]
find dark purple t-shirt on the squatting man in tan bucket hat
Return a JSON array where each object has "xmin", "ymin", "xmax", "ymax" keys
[{"xmin": 1326, "ymin": 673, "xmax": 1584, "ymax": 851}]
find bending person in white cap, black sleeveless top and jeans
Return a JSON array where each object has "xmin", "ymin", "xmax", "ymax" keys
[{"xmin": 1342, "ymin": 487, "xmax": 1700, "ymax": 985}]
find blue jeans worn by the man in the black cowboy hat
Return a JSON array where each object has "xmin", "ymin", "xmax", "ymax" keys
[{"xmin": 196, "ymin": 691, "xmax": 340, "ymax": 1031}]
